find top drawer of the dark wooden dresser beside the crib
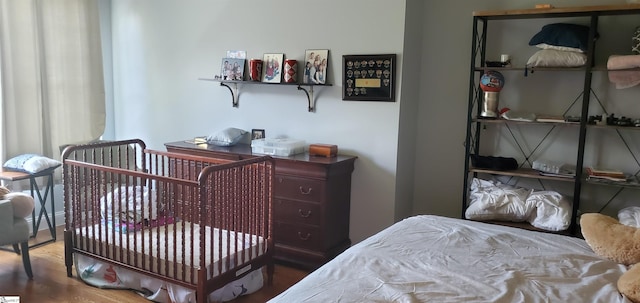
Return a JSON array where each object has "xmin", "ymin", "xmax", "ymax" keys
[{"xmin": 275, "ymin": 176, "xmax": 324, "ymax": 202}]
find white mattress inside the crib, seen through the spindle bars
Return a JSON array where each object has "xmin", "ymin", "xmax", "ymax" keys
[{"xmin": 76, "ymin": 222, "xmax": 266, "ymax": 284}]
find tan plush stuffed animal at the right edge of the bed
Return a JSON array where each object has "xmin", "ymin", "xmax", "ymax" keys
[{"xmin": 580, "ymin": 213, "xmax": 640, "ymax": 303}]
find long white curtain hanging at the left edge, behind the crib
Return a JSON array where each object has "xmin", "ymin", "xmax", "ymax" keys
[{"xmin": 0, "ymin": 0, "xmax": 105, "ymax": 169}]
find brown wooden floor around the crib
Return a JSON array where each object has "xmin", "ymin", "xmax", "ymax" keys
[{"xmin": 0, "ymin": 229, "xmax": 308, "ymax": 303}]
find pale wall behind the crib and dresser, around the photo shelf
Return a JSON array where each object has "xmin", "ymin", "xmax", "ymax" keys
[{"xmin": 105, "ymin": 0, "xmax": 404, "ymax": 242}]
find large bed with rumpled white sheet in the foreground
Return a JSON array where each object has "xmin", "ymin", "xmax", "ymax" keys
[{"xmin": 268, "ymin": 215, "xmax": 630, "ymax": 303}]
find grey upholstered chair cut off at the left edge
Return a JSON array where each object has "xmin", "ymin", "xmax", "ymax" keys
[{"xmin": 0, "ymin": 192, "xmax": 34, "ymax": 279}]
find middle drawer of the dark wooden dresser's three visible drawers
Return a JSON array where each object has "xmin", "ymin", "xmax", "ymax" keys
[{"xmin": 273, "ymin": 198, "xmax": 321, "ymax": 226}]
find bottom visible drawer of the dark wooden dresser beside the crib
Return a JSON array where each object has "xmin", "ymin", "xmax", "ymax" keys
[{"xmin": 273, "ymin": 221, "xmax": 322, "ymax": 250}]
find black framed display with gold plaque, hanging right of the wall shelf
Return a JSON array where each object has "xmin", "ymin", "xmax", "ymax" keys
[{"xmin": 342, "ymin": 54, "xmax": 396, "ymax": 102}]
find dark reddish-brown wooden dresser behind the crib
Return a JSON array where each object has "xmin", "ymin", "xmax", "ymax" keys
[{"xmin": 165, "ymin": 141, "xmax": 356, "ymax": 269}]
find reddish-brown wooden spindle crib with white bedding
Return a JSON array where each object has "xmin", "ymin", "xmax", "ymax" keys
[{"xmin": 62, "ymin": 139, "xmax": 274, "ymax": 303}]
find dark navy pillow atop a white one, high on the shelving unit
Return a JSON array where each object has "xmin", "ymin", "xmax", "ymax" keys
[{"xmin": 529, "ymin": 23, "xmax": 598, "ymax": 52}]
